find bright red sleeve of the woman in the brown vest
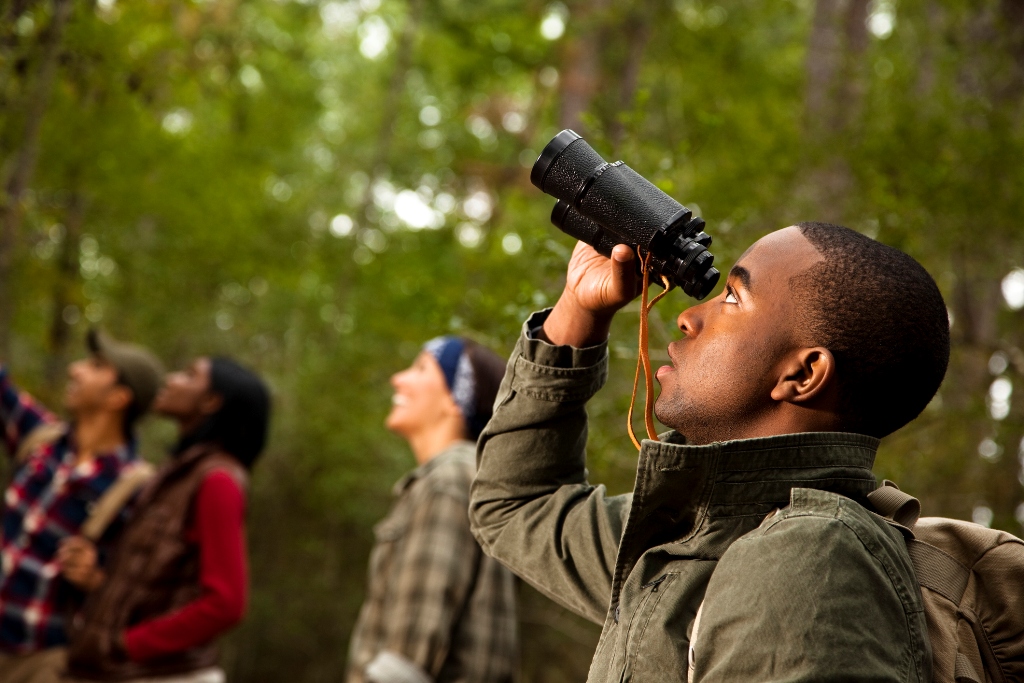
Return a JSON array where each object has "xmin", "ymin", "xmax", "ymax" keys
[{"xmin": 124, "ymin": 470, "xmax": 249, "ymax": 661}]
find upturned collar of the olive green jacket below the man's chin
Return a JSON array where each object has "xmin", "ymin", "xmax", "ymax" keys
[{"xmin": 612, "ymin": 432, "xmax": 879, "ymax": 600}]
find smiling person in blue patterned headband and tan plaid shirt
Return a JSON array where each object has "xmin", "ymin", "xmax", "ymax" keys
[{"xmin": 347, "ymin": 337, "xmax": 518, "ymax": 683}]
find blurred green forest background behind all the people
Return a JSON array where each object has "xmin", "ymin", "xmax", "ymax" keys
[{"xmin": 0, "ymin": 0, "xmax": 1024, "ymax": 683}]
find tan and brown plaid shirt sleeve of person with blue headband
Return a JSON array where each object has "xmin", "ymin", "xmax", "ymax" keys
[{"xmin": 376, "ymin": 481, "xmax": 481, "ymax": 683}]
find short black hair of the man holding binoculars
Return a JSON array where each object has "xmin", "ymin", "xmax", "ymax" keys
[{"xmin": 790, "ymin": 222, "xmax": 949, "ymax": 438}]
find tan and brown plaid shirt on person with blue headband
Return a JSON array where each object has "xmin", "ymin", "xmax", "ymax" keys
[{"xmin": 347, "ymin": 441, "xmax": 518, "ymax": 683}]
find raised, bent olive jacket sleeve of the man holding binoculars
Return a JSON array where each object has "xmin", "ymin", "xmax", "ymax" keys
[{"xmin": 470, "ymin": 311, "xmax": 631, "ymax": 624}]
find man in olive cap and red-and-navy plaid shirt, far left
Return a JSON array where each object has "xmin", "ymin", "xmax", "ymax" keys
[{"xmin": 0, "ymin": 331, "xmax": 163, "ymax": 683}]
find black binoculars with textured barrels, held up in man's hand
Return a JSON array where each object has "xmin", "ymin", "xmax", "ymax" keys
[{"xmin": 529, "ymin": 129, "xmax": 719, "ymax": 300}]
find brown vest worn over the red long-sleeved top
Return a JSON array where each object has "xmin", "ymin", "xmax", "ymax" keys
[{"xmin": 68, "ymin": 443, "xmax": 247, "ymax": 681}]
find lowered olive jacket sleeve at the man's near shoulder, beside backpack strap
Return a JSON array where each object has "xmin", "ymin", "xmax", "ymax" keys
[{"xmin": 691, "ymin": 511, "xmax": 930, "ymax": 683}]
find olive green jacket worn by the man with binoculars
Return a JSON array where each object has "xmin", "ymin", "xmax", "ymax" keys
[{"xmin": 470, "ymin": 313, "xmax": 931, "ymax": 683}]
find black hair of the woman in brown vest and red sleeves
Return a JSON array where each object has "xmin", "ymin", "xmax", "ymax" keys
[{"xmin": 174, "ymin": 357, "xmax": 270, "ymax": 469}]
